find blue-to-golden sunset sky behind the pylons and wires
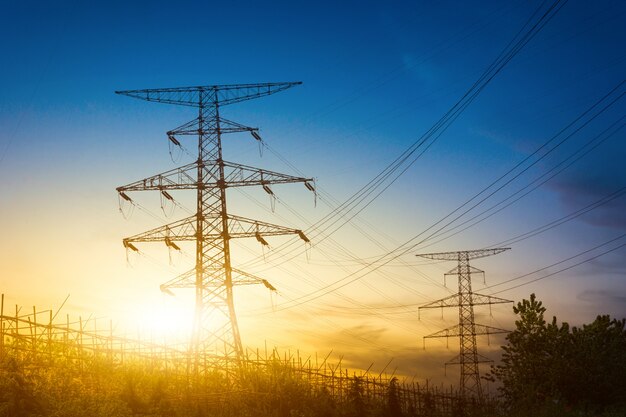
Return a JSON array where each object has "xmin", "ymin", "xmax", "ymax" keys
[{"xmin": 0, "ymin": 1, "xmax": 626, "ymax": 383}]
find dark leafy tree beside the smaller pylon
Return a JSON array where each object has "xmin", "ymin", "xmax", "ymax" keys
[{"xmin": 488, "ymin": 294, "xmax": 626, "ymax": 416}]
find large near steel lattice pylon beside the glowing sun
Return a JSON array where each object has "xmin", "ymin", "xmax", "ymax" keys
[{"xmin": 115, "ymin": 82, "xmax": 315, "ymax": 372}]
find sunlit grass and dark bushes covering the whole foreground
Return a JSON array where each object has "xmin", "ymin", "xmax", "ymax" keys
[{"xmin": 0, "ymin": 295, "xmax": 626, "ymax": 417}]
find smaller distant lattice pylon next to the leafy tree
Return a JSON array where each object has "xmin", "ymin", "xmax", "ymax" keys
[{"xmin": 416, "ymin": 248, "xmax": 513, "ymax": 401}]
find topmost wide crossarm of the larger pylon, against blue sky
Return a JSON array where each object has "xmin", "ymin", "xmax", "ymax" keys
[{"xmin": 115, "ymin": 81, "xmax": 302, "ymax": 107}]
